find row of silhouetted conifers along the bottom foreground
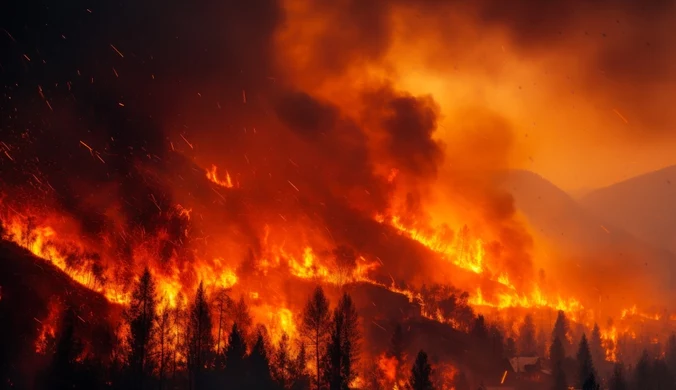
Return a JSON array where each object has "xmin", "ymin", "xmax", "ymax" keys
[{"xmin": 30, "ymin": 270, "xmax": 676, "ymax": 390}]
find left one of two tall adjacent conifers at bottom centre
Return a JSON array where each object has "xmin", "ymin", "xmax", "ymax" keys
[{"xmin": 302, "ymin": 286, "xmax": 330, "ymax": 389}]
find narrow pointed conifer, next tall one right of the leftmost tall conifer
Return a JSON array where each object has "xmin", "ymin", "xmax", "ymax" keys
[{"xmin": 188, "ymin": 282, "xmax": 214, "ymax": 390}]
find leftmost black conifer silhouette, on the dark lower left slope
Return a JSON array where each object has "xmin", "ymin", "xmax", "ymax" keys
[{"xmin": 46, "ymin": 308, "xmax": 82, "ymax": 390}]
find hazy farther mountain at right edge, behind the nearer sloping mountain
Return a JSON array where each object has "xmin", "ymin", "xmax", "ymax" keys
[{"xmin": 580, "ymin": 166, "xmax": 676, "ymax": 253}]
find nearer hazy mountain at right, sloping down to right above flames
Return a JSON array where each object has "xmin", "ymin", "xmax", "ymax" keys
[{"xmin": 502, "ymin": 170, "xmax": 676, "ymax": 310}]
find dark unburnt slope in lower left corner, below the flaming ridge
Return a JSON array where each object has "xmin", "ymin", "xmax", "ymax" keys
[{"xmin": 0, "ymin": 240, "xmax": 119, "ymax": 388}]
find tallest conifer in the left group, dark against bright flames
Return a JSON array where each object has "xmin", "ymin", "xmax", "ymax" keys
[{"xmin": 125, "ymin": 268, "xmax": 157, "ymax": 389}]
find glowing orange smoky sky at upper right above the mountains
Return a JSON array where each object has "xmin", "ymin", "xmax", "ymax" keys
[{"xmin": 277, "ymin": 0, "xmax": 676, "ymax": 193}]
